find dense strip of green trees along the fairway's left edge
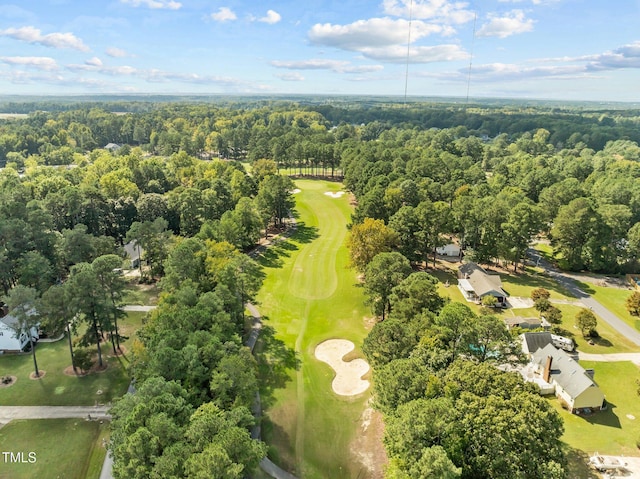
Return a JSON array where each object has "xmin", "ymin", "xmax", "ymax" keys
[{"xmin": 110, "ymin": 238, "xmax": 266, "ymax": 478}]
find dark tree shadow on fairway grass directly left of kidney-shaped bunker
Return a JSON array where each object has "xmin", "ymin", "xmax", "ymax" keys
[{"xmin": 254, "ymin": 324, "xmax": 302, "ymax": 408}]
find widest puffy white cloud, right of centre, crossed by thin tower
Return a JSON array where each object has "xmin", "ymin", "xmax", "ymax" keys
[{"xmin": 309, "ymin": 17, "xmax": 452, "ymax": 51}]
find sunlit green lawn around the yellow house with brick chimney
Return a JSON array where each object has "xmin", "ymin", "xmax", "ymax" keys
[{"xmin": 549, "ymin": 361, "xmax": 640, "ymax": 456}]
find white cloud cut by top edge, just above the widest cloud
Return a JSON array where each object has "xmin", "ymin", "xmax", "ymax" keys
[{"xmin": 382, "ymin": 0, "xmax": 474, "ymax": 24}]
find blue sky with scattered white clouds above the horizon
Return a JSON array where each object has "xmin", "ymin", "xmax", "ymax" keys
[{"xmin": 0, "ymin": 0, "xmax": 640, "ymax": 101}]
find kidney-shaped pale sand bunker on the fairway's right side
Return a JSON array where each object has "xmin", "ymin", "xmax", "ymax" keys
[{"xmin": 315, "ymin": 339, "xmax": 369, "ymax": 396}]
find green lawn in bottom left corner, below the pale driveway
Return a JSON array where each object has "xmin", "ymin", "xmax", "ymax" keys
[{"xmin": 0, "ymin": 419, "xmax": 108, "ymax": 479}]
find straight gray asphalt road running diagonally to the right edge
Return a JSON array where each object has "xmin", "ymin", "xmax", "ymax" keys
[{"xmin": 527, "ymin": 248, "xmax": 640, "ymax": 347}]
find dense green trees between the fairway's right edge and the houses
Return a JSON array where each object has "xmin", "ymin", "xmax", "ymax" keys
[{"xmin": 362, "ymin": 252, "xmax": 566, "ymax": 479}]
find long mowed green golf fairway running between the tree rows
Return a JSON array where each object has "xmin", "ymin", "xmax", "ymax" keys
[{"xmin": 258, "ymin": 180, "xmax": 370, "ymax": 478}]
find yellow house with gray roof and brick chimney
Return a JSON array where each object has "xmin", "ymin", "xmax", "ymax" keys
[{"xmin": 531, "ymin": 344, "xmax": 607, "ymax": 414}]
